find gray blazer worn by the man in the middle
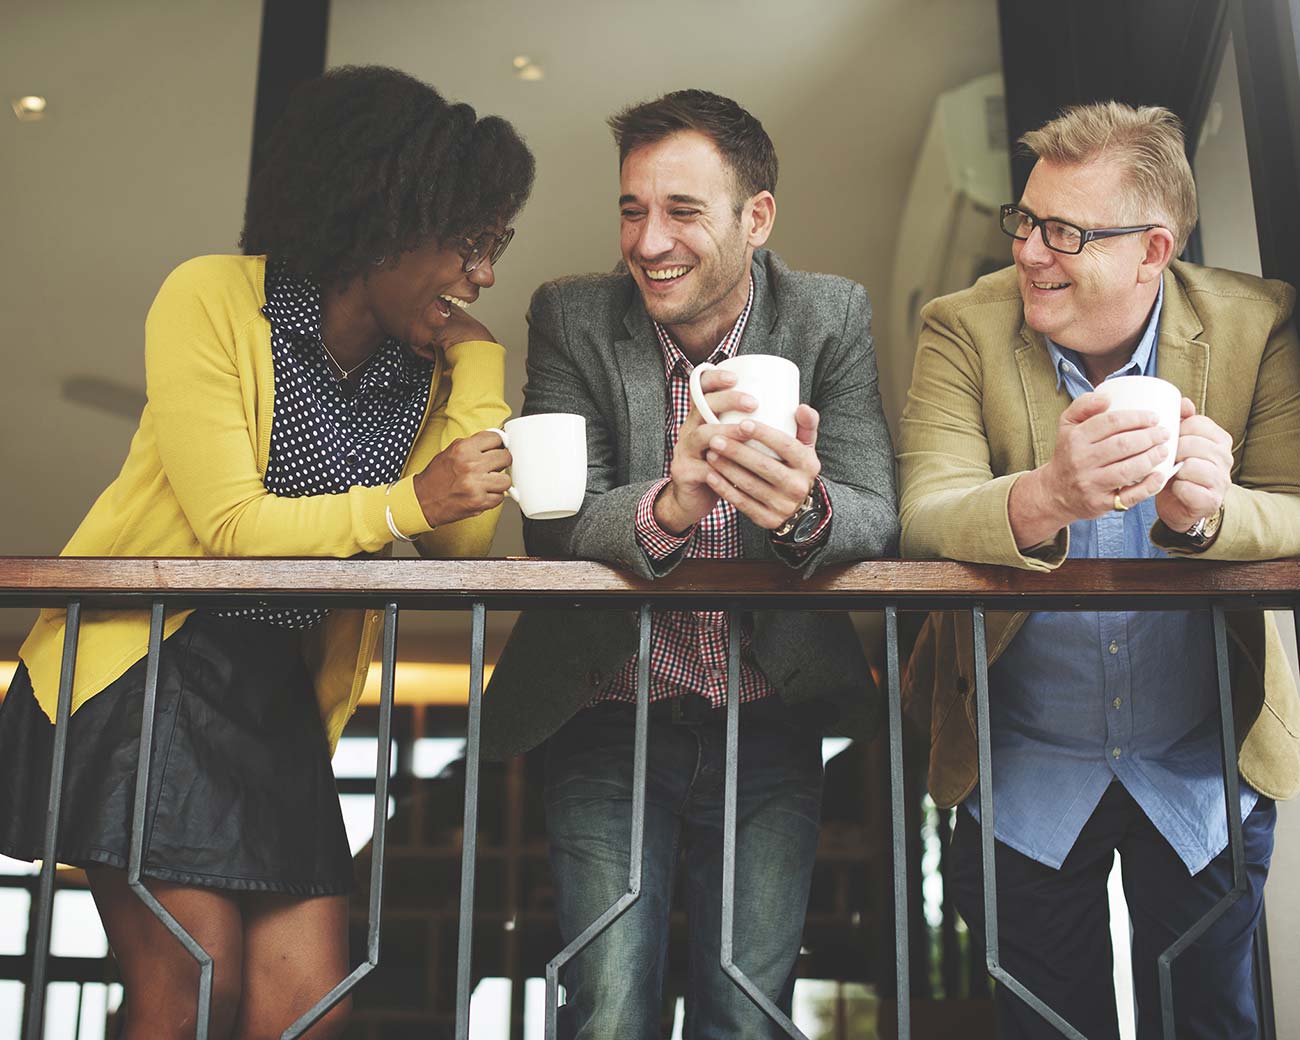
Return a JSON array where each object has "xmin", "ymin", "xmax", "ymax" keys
[{"xmin": 482, "ymin": 250, "xmax": 898, "ymax": 758}]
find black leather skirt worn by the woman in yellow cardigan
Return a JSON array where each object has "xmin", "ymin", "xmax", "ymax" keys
[{"xmin": 0, "ymin": 611, "xmax": 352, "ymax": 896}]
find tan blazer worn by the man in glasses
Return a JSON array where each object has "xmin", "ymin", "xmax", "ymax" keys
[{"xmin": 898, "ymin": 261, "xmax": 1300, "ymax": 806}]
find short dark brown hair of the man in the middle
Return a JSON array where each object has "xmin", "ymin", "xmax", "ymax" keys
[{"xmin": 608, "ymin": 90, "xmax": 776, "ymax": 205}]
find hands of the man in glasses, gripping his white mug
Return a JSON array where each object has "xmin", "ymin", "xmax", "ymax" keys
[{"xmin": 1011, "ymin": 394, "xmax": 1232, "ymax": 546}]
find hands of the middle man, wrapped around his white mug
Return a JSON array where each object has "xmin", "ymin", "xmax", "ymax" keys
[{"xmin": 654, "ymin": 369, "xmax": 822, "ymax": 534}]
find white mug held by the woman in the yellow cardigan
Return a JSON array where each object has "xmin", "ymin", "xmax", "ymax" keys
[{"xmin": 491, "ymin": 412, "xmax": 586, "ymax": 520}]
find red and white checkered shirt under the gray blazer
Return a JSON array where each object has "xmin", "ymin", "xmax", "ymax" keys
[{"xmin": 595, "ymin": 280, "xmax": 831, "ymax": 707}]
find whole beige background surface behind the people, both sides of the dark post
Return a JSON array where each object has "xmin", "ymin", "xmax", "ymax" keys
[{"xmin": 0, "ymin": 0, "xmax": 1000, "ymax": 650}]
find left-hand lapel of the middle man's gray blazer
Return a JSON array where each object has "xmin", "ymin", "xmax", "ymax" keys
[{"xmin": 614, "ymin": 289, "xmax": 668, "ymax": 484}]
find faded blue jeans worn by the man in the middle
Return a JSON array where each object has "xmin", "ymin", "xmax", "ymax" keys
[{"xmin": 546, "ymin": 697, "xmax": 822, "ymax": 1040}]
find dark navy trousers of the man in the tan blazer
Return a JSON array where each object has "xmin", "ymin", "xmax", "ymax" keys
[{"xmin": 953, "ymin": 783, "xmax": 1281, "ymax": 1040}]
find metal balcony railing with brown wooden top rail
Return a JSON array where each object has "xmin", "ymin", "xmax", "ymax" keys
[{"xmin": 0, "ymin": 558, "xmax": 1300, "ymax": 1040}]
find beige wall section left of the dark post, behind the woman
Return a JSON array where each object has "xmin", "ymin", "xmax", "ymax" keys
[{"xmin": 0, "ymin": 0, "xmax": 261, "ymax": 564}]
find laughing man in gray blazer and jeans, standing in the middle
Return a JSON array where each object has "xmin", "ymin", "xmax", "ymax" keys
[{"xmin": 484, "ymin": 90, "xmax": 898, "ymax": 1040}]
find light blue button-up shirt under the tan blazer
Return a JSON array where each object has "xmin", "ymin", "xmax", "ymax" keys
[{"xmin": 966, "ymin": 280, "xmax": 1258, "ymax": 874}]
